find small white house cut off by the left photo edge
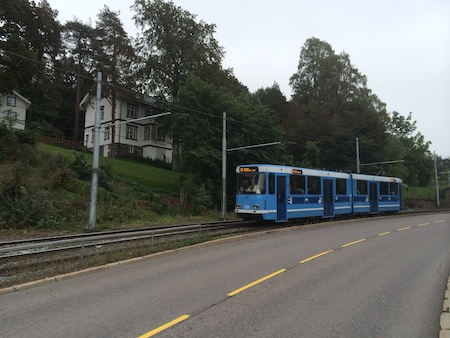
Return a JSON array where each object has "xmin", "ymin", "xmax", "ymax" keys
[{"xmin": 0, "ymin": 90, "xmax": 31, "ymax": 130}]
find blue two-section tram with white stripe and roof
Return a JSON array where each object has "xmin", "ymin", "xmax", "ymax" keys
[{"xmin": 234, "ymin": 164, "xmax": 402, "ymax": 222}]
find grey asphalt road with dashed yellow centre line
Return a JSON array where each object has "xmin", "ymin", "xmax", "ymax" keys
[{"xmin": 0, "ymin": 213, "xmax": 450, "ymax": 338}]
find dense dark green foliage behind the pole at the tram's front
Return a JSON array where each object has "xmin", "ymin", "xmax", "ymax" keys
[{"xmin": 166, "ymin": 76, "xmax": 289, "ymax": 205}]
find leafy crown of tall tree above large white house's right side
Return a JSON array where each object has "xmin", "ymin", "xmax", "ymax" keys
[{"xmin": 133, "ymin": 0, "xmax": 223, "ymax": 97}]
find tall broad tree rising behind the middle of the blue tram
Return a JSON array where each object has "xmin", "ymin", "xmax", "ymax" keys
[{"xmin": 290, "ymin": 38, "xmax": 387, "ymax": 170}]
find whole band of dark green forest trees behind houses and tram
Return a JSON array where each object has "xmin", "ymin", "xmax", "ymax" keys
[{"xmin": 0, "ymin": 0, "xmax": 450, "ymax": 230}]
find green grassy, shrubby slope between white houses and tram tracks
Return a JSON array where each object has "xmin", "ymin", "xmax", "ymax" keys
[{"xmin": 0, "ymin": 132, "xmax": 200, "ymax": 231}]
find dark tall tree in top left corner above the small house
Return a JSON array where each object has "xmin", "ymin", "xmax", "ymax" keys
[{"xmin": 0, "ymin": 0, "xmax": 61, "ymax": 122}]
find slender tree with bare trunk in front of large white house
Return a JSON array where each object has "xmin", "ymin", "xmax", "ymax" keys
[{"xmin": 94, "ymin": 5, "xmax": 136, "ymax": 157}]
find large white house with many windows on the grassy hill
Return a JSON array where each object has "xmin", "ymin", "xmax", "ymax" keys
[{"xmin": 80, "ymin": 93, "xmax": 172, "ymax": 163}]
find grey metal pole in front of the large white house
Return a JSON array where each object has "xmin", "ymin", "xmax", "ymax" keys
[{"xmin": 87, "ymin": 72, "xmax": 102, "ymax": 230}]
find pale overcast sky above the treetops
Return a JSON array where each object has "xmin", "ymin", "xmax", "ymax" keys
[{"xmin": 48, "ymin": 0, "xmax": 450, "ymax": 158}]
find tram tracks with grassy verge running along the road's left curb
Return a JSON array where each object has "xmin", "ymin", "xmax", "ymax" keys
[{"xmin": 0, "ymin": 210, "xmax": 442, "ymax": 289}]
